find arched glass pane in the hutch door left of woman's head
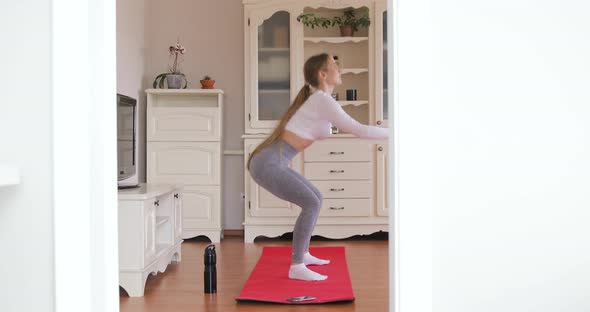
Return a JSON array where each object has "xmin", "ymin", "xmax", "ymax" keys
[{"xmin": 258, "ymin": 11, "xmax": 291, "ymax": 120}]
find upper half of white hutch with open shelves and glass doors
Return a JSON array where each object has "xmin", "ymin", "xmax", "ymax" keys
[{"xmin": 243, "ymin": 0, "xmax": 388, "ymax": 134}]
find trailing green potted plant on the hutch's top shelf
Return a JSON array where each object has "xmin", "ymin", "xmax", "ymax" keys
[{"xmin": 297, "ymin": 9, "xmax": 371, "ymax": 37}]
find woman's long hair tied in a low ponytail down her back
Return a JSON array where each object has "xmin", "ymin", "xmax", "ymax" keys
[{"xmin": 247, "ymin": 53, "xmax": 329, "ymax": 170}]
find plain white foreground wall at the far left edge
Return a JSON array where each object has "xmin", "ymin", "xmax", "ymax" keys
[{"xmin": 0, "ymin": 0, "xmax": 55, "ymax": 312}]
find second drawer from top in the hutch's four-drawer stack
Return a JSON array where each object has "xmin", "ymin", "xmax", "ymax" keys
[{"xmin": 303, "ymin": 162, "xmax": 372, "ymax": 180}]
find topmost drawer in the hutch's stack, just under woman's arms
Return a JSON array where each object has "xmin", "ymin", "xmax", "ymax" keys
[{"xmin": 303, "ymin": 140, "xmax": 375, "ymax": 162}]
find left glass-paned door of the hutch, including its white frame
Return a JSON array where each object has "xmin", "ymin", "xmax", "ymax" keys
[{"xmin": 245, "ymin": 8, "xmax": 297, "ymax": 133}]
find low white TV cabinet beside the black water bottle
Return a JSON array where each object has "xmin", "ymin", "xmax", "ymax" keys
[{"xmin": 118, "ymin": 183, "xmax": 182, "ymax": 297}]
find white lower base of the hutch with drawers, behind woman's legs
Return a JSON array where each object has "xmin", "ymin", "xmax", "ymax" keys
[{"xmin": 244, "ymin": 136, "xmax": 388, "ymax": 242}]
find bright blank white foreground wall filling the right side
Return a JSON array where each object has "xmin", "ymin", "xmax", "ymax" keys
[{"xmin": 396, "ymin": 0, "xmax": 590, "ymax": 312}]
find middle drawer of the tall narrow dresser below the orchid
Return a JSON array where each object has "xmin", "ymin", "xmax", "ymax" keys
[{"xmin": 146, "ymin": 142, "xmax": 221, "ymax": 185}]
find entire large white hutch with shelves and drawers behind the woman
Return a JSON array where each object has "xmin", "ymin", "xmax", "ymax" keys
[{"xmin": 243, "ymin": 0, "xmax": 390, "ymax": 242}]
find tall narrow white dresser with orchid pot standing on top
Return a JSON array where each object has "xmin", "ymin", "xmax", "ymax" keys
[{"xmin": 146, "ymin": 89, "xmax": 223, "ymax": 242}]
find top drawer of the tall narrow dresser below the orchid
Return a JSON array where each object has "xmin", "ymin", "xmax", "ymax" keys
[{"xmin": 146, "ymin": 94, "xmax": 221, "ymax": 141}]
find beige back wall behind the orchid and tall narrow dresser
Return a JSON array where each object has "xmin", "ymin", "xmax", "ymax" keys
[{"xmin": 146, "ymin": 0, "xmax": 244, "ymax": 229}]
